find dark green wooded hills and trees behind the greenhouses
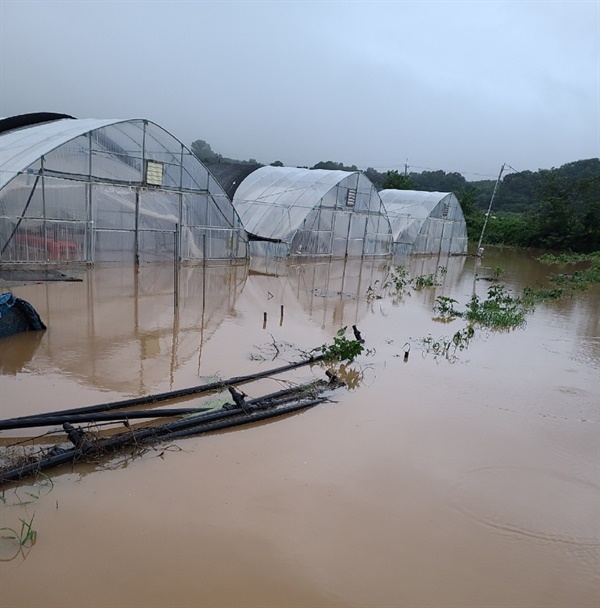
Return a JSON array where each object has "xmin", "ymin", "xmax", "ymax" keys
[{"xmin": 191, "ymin": 139, "xmax": 600, "ymax": 253}]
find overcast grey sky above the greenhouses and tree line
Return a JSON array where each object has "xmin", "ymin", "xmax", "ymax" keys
[{"xmin": 0, "ymin": 0, "xmax": 600, "ymax": 179}]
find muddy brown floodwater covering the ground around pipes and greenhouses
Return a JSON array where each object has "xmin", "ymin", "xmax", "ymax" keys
[{"xmin": 0, "ymin": 248, "xmax": 600, "ymax": 608}]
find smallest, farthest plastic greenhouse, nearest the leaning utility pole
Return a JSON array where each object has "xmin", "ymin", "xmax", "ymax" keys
[{"xmin": 379, "ymin": 190, "xmax": 467, "ymax": 255}]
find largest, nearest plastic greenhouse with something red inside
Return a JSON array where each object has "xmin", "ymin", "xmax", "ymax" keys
[{"xmin": 0, "ymin": 115, "xmax": 248, "ymax": 263}]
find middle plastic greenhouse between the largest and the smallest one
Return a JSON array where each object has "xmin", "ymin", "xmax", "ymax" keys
[{"xmin": 233, "ymin": 166, "xmax": 392, "ymax": 258}]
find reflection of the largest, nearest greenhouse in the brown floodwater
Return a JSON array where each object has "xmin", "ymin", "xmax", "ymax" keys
[{"xmin": 0, "ymin": 264, "xmax": 247, "ymax": 395}]
